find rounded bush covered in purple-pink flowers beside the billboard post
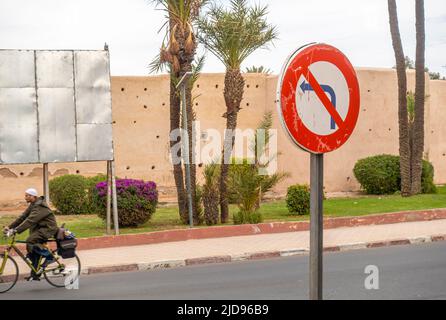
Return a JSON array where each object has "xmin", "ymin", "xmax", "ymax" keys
[{"xmin": 94, "ymin": 179, "xmax": 158, "ymax": 227}]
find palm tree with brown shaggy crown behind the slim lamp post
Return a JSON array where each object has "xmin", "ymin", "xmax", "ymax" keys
[{"xmin": 150, "ymin": 0, "xmax": 206, "ymax": 224}]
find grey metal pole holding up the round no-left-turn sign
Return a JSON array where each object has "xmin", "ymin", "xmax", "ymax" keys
[{"xmin": 310, "ymin": 153, "xmax": 324, "ymax": 300}]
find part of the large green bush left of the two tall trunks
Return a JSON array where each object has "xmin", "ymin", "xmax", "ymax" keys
[{"xmin": 353, "ymin": 154, "xmax": 401, "ymax": 194}]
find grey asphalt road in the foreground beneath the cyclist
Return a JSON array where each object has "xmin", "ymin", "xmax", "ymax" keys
[{"xmin": 1, "ymin": 242, "xmax": 446, "ymax": 300}]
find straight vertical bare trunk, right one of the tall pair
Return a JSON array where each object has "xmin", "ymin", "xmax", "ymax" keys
[{"xmin": 411, "ymin": 0, "xmax": 425, "ymax": 194}]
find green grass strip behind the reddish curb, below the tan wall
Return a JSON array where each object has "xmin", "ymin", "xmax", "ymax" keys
[{"xmin": 0, "ymin": 186, "xmax": 446, "ymax": 244}]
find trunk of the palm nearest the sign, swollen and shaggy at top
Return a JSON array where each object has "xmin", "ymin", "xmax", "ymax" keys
[{"xmin": 220, "ymin": 69, "xmax": 245, "ymax": 223}]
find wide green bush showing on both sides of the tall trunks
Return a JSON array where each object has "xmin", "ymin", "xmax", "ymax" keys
[{"xmin": 353, "ymin": 154, "xmax": 437, "ymax": 194}]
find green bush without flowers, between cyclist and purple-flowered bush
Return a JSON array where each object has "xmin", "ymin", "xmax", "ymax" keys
[{"xmin": 49, "ymin": 174, "xmax": 90, "ymax": 215}]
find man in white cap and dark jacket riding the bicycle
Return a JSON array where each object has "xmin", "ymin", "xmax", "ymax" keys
[{"xmin": 4, "ymin": 188, "xmax": 58, "ymax": 281}]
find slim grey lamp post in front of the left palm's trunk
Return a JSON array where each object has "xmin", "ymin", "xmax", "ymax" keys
[{"xmin": 176, "ymin": 72, "xmax": 194, "ymax": 228}]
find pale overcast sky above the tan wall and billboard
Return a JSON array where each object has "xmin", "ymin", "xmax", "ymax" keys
[{"xmin": 0, "ymin": 0, "xmax": 446, "ymax": 76}]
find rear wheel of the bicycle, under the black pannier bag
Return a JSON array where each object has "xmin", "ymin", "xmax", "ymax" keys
[{"xmin": 43, "ymin": 255, "xmax": 81, "ymax": 289}]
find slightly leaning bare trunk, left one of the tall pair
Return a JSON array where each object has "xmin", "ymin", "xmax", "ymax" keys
[{"xmin": 388, "ymin": 0, "xmax": 411, "ymax": 197}]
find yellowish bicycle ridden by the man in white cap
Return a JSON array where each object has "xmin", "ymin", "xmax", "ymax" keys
[{"xmin": 0, "ymin": 234, "xmax": 81, "ymax": 293}]
